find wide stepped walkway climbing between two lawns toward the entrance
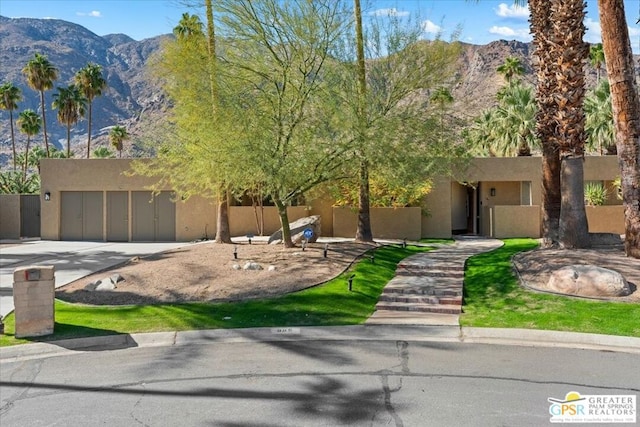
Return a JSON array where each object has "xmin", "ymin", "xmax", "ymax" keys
[{"xmin": 366, "ymin": 237, "xmax": 502, "ymax": 325}]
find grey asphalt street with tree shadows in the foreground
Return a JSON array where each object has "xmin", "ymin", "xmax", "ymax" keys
[{"xmin": 0, "ymin": 327, "xmax": 640, "ymax": 427}]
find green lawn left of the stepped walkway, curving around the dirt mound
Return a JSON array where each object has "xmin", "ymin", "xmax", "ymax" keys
[{"xmin": 0, "ymin": 246, "xmax": 432, "ymax": 346}]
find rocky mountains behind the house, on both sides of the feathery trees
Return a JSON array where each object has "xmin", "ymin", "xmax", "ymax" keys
[{"xmin": 0, "ymin": 16, "xmax": 640, "ymax": 166}]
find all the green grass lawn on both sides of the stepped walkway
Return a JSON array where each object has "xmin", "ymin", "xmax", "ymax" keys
[{"xmin": 0, "ymin": 239, "xmax": 640, "ymax": 346}]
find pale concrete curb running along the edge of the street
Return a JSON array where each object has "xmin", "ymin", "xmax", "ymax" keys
[{"xmin": 5, "ymin": 325, "xmax": 640, "ymax": 363}]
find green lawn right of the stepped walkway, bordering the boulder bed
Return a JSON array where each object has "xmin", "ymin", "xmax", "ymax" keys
[{"xmin": 460, "ymin": 239, "xmax": 640, "ymax": 337}]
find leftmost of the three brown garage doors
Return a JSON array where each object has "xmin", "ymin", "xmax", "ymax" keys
[{"xmin": 60, "ymin": 191, "xmax": 104, "ymax": 240}]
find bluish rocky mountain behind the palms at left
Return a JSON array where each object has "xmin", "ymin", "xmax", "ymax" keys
[{"xmin": 0, "ymin": 16, "xmax": 170, "ymax": 163}]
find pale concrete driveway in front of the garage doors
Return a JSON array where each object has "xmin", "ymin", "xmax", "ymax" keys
[{"xmin": 0, "ymin": 240, "xmax": 191, "ymax": 317}]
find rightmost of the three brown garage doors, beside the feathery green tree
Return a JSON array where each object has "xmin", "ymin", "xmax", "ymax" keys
[{"xmin": 131, "ymin": 191, "xmax": 176, "ymax": 242}]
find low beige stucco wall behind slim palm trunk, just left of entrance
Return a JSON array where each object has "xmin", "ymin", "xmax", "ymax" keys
[{"xmin": 333, "ymin": 207, "xmax": 422, "ymax": 240}]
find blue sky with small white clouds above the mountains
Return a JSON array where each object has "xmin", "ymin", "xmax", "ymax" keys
[{"xmin": 0, "ymin": 0, "xmax": 640, "ymax": 53}]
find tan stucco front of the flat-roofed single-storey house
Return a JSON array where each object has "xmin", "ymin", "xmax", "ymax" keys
[{"xmin": 15, "ymin": 156, "xmax": 624, "ymax": 241}]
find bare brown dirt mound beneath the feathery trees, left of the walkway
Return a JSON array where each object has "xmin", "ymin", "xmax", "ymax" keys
[{"xmin": 56, "ymin": 242, "xmax": 376, "ymax": 305}]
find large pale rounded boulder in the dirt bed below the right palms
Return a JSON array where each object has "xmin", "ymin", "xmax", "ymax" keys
[{"xmin": 546, "ymin": 265, "xmax": 631, "ymax": 297}]
